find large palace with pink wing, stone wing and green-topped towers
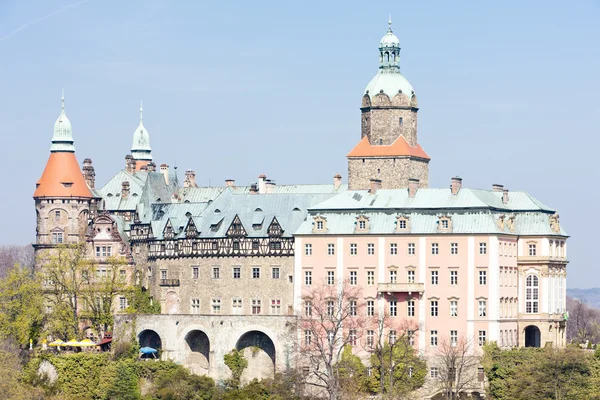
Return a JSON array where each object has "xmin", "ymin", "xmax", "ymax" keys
[{"xmin": 33, "ymin": 22, "xmax": 568, "ymax": 396}]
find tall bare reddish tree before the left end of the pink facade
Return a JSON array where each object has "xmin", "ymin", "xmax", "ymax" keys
[{"xmin": 295, "ymin": 282, "xmax": 367, "ymax": 400}]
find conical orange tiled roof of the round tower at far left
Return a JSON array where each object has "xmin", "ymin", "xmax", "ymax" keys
[{"xmin": 33, "ymin": 152, "xmax": 92, "ymax": 198}]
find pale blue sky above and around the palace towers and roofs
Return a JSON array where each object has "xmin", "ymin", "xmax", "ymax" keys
[{"xmin": 0, "ymin": 0, "xmax": 600, "ymax": 287}]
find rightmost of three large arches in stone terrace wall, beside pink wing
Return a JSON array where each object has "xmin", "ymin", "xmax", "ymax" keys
[{"xmin": 235, "ymin": 331, "xmax": 276, "ymax": 383}]
